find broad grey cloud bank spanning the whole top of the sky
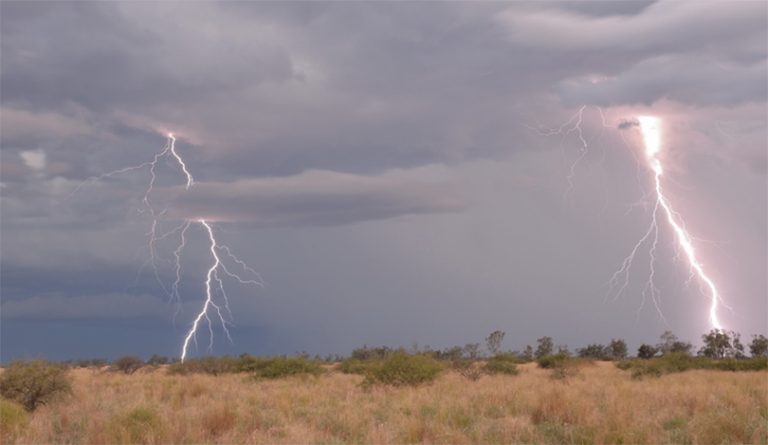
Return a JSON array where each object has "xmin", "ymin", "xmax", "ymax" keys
[{"xmin": 2, "ymin": 2, "xmax": 766, "ymax": 184}]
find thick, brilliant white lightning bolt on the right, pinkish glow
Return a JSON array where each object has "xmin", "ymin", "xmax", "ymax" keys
[{"xmin": 609, "ymin": 116, "xmax": 728, "ymax": 330}]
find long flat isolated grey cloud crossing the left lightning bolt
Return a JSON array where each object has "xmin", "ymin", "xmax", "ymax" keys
[{"xmin": 169, "ymin": 169, "xmax": 465, "ymax": 227}]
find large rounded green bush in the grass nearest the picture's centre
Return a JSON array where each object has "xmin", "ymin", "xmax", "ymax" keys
[{"xmin": 364, "ymin": 352, "xmax": 443, "ymax": 386}]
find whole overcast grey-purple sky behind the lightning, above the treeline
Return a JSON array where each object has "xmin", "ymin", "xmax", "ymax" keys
[{"xmin": 0, "ymin": 1, "xmax": 768, "ymax": 360}]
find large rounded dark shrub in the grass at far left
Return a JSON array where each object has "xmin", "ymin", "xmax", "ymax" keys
[{"xmin": 0, "ymin": 360, "xmax": 72, "ymax": 411}]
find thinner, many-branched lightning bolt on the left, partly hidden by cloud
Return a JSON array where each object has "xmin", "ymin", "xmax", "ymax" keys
[{"xmin": 72, "ymin": 133, "xmax": 262, "ymax": 362}]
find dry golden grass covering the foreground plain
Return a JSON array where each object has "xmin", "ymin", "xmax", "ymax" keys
[{"xmin": 0, "ymin": 363, "xmax": 768, "ymax": 444}]
